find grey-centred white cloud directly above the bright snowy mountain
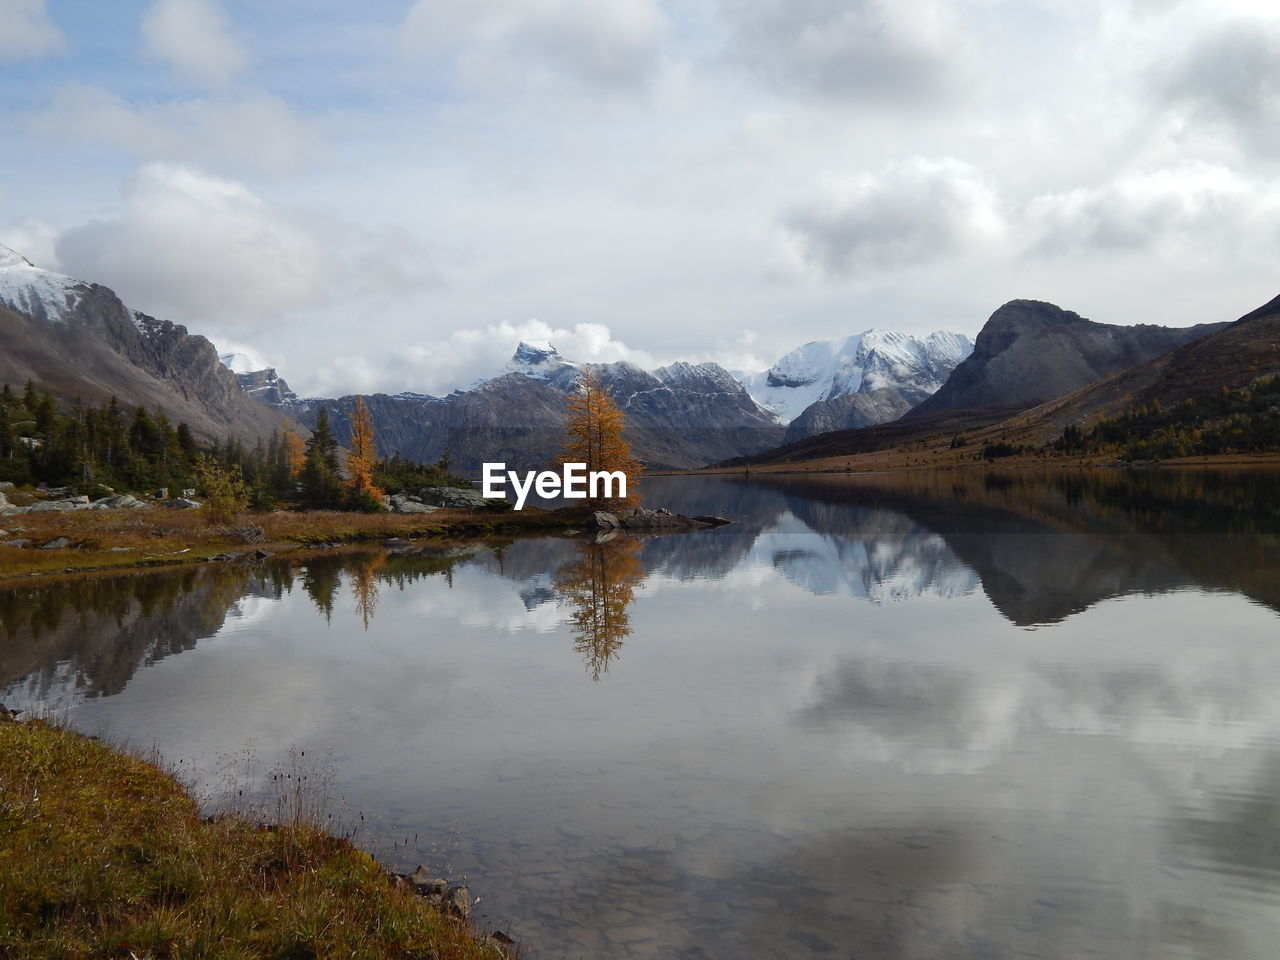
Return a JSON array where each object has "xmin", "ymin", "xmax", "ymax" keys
[{"xmin": 781, "ymin": 159, "xmax": 1005, "ymax": 276}]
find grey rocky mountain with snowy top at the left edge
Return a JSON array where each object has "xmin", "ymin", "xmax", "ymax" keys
[{"xmin": 0, "ymin": 246, "xmax": 289, "ymax": 442}]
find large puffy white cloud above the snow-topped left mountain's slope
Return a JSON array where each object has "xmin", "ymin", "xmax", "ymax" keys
[{"xmin": 56, "ymin": 164, "xmax": 436, "ymax": 328}]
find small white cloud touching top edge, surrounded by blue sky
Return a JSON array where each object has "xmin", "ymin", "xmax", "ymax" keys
[{"xmin": 142, "ymin": 0, "xmax": 248, "ymax": 86}]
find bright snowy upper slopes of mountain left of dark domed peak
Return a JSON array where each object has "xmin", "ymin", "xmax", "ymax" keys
[{"xmin": 741, "ymin": 329, "xmax": 973, "ymax": 422}]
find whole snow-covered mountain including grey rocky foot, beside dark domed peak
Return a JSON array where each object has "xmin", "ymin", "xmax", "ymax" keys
[{"xmin": 741, "ymin": 329, "xmax": 973, "ymax": 442}]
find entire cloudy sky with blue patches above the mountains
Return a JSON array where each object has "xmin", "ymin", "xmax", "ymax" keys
[{"xmin": 0, "ymin": 0, "xmax": 1280, "ymax": 394}]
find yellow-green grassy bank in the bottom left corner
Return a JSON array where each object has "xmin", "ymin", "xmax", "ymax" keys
[{"xmin": 0, "ymin": 717, "xmax": 508, "ymax": 960}]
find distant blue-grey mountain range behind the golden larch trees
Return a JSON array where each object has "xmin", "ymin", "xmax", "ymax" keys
[{"xmin": 268, "ymin": 343, "xmax": 783, "ymax": 474}]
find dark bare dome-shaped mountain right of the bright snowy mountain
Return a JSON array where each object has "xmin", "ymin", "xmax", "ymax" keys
[{"xmin": 909, "ymin": 300, "xmax": 1224, "ymax": 417}]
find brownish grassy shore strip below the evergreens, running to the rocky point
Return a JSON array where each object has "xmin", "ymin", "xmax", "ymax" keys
[{"xmin": 0, "ymin": 507, "xmax": 584, "ymax": 581}]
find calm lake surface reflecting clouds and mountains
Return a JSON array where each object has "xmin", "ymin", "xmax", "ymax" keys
[{"xmin": 0, "ymin": 471, "xmax": 1280, "ymax": 960}]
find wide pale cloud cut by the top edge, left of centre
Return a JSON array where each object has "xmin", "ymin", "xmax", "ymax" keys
[{"xmin": 401, "ymin": 0, "xmax": 667, "ymax": 90}]
